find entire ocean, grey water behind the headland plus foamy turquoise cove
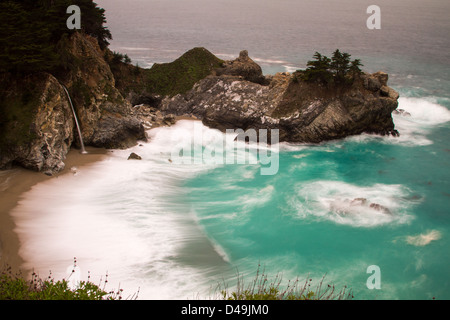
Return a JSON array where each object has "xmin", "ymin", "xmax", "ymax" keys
[{"xmin": 8, "ymin": 0, "xmax": 450, "ymax": 300}]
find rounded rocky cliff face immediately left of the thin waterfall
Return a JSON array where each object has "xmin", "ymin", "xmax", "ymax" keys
[{"xmin": 0, "ymin": 73, "xmax": 74, "ymax": 173}]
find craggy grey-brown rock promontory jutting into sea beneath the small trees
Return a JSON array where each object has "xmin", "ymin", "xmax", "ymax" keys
[{"xmin": 161, "ymin": 52, "xmax": 398, "ymax": 143}]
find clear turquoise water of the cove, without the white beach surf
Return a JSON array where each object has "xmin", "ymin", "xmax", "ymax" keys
[{"xmin": 182, "ymin": 106, "xmax": 450, "ymax": 299}]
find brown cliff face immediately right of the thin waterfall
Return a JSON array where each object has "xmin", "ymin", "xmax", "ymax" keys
[{"xmin": 61, "ymin": 33, "xmax": 145, "ymax": 148}]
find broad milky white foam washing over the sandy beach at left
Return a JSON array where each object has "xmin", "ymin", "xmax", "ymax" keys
[{"xmin": 12, "ymin": 123, "xmax": 239, "ymax": 299}]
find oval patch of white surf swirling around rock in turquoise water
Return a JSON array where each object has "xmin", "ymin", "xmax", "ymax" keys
[{"xmin": 289, "ymin": 180, "xmax": 412, "ymax": 227}]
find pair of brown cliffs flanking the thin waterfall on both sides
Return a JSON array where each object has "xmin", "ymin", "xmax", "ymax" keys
[{"xmin": 0, "ymin": 33, "xmax": 146, "ymax": 174}]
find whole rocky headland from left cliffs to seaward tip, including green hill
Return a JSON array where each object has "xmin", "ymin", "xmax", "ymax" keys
[{"xmin": 0, "ymin": 32, "xmax": 399, "ymax": 174}]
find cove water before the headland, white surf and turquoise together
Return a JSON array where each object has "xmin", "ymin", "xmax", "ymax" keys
[{"xmin": 13, "ymin": 102, "xmax": 450, "ymax": 299}]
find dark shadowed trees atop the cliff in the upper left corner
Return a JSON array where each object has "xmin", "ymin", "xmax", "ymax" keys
[{"xmin": 0, "ymin": 0, "xmax": 112, "ymax": 74}]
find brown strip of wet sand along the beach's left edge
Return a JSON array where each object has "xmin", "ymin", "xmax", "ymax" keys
[{"xmin": 0, "ymin": 147, "xmax": 108, "ymax": 273}]
